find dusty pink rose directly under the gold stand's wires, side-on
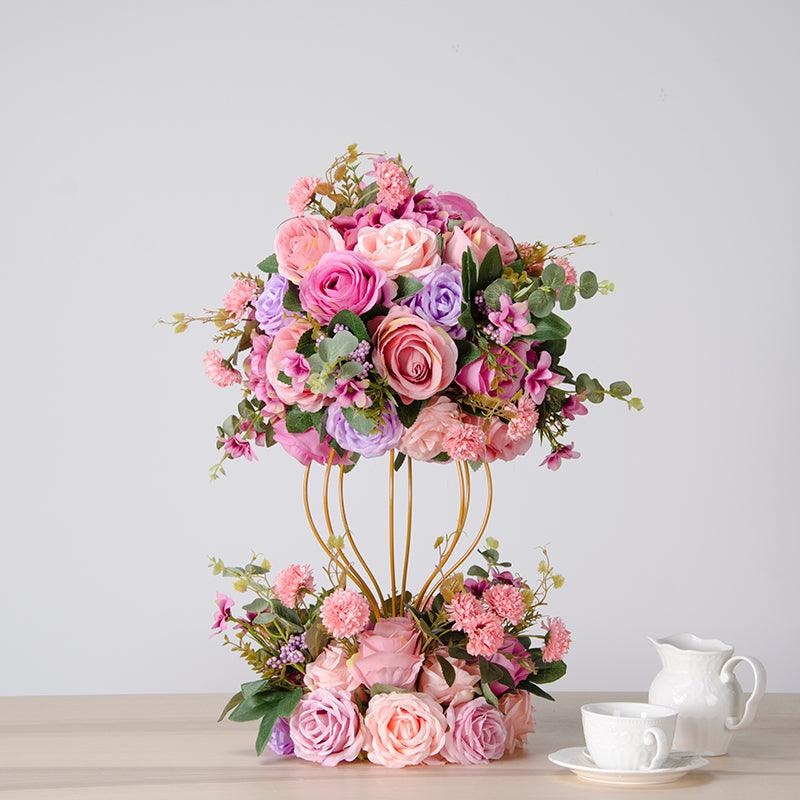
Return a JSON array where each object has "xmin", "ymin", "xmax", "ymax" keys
[{"xmin": 350, "ymin": 617, "xmax": 424, "ymax": 689}]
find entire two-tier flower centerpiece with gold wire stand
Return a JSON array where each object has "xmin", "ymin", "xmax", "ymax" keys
[{"xmin": 169, "ymin": 145, "xmax": 642, "ymax": 767}]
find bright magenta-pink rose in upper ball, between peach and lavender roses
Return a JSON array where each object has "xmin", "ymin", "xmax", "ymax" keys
[{"xmin": 300, "ymin": 250, "xmax": 395, "ymax": 323}]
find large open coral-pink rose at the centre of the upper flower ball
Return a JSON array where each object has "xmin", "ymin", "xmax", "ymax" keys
[{"xmin": 372, "ymin": 306, "xmax": 458, "ymax": 403}]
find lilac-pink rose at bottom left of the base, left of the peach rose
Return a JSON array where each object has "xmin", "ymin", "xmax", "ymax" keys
[{"xmin": 289, "ymin": 689, "xmax": 364, "ymax": 767}]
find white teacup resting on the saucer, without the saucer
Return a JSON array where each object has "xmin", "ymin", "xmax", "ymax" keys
[{"xmin": 581, "ymin": 703, "xmax": 678, "ymax": 770}]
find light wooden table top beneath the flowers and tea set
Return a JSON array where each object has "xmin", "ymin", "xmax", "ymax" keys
[{"xmin": 0, "ymin": 692, "xmax": 800, "ymax": 800}]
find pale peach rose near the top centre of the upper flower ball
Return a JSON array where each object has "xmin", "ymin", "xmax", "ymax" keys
[{"xmin": 354, "ymin": 219, "xmax": 444, "ymax": 278}]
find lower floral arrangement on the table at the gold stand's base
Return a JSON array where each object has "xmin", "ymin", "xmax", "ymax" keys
[{"xmin": 211, "ymin": 538, "xmax": 570, "ymax": 767}]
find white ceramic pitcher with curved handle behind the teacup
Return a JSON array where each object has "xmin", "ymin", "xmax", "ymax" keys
[{"xmin": 648, "ymin": 633, "xmax": 767, "ymax": 756}]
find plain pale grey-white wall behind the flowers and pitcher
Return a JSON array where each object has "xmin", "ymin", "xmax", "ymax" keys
[{"xmin": 0, "ymin": 0, "xmax": 800, "ymax": 694}]
